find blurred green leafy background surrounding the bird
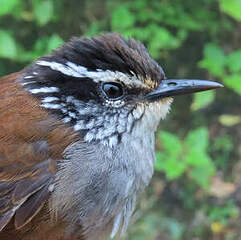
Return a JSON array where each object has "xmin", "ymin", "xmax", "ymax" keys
[{"xmin": 0, "ymin": 0, "xmax": 241, "ymax": 240}]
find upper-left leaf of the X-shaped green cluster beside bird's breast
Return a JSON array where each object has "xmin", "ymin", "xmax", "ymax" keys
[{"xmin": 158, "ymin": 131, "xmax": 182, "ymax": 155}]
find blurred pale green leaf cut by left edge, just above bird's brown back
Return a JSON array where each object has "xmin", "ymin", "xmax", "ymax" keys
[{"xmin": 0, "ymin": 30, "xmax": 17, "ymax": 59}]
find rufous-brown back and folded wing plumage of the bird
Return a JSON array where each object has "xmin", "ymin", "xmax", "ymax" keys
[{"xmin": 0, "ymin": 73, "xmax": 78, "ymax": 239}]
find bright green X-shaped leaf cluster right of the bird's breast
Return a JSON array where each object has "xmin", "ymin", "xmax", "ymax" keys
[{"xmin": 155, "ymin": 128, "xmax": 215, "ymax": 188}]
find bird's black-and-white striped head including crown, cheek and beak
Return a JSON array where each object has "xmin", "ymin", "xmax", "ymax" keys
[{"xmin": 22, "ymin": 33, "xmax": 221, "ymax": 147}]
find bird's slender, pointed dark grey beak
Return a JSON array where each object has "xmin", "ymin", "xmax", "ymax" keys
[{"xmin": 145, "ymin": 79, "xmax": 223, "ymax": 101}]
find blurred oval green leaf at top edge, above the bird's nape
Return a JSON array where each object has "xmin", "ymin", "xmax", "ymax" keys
[{"xmin": 33, "ymin": 0, "xmax": 54, "ymax": 26}]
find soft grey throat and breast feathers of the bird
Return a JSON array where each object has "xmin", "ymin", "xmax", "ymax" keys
[{"xmin": 52, "ymin": 99, "xmax": 171, "ymax": 240}]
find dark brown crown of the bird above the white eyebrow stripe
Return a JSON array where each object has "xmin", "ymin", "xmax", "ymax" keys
[{"xmin": 38, "ymin": 33, "xmax": 164, "ymax": 86}]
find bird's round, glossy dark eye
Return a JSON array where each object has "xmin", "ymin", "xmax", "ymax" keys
[{"xmin": 101, "ymin": 82, "xmax": 124, "ymax": 100}]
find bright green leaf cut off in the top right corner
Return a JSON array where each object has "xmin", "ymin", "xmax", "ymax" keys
[{"xmin": 220, "ymin": 0, "xmax": 241, "ymax": 21}]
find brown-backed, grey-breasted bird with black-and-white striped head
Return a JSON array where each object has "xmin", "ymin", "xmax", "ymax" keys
[{"xmin": 0, "ymin": 33, "xmax": 222, "ymax": 240}]
